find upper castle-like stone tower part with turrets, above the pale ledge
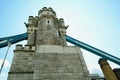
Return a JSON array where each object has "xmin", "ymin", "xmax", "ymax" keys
[{"xmin": 25, "ymin": 7, "xmax": 67, "ymax": 46}]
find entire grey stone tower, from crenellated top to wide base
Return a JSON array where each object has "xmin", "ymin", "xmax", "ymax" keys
[{"xmin": 8, "ymin": 7, "xmax": 90, "ymax": 80}]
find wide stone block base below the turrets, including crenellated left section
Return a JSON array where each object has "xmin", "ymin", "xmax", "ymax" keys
[{"xmin": 8, "ymin": 45, "xmax": 90, "ymax": 80}]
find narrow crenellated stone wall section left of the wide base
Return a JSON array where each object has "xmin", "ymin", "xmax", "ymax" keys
[{"xmin": 8, "ymin": 45, "xmax": 35, "ymax": 80}]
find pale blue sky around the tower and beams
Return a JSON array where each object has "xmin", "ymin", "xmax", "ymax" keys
[{"xmin": 0, "ymin": 0, "xmax": 120, "ymax": 80}]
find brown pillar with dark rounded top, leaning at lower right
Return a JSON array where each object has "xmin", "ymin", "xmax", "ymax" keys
[{"xmin": 99, "ymin": 58, "xmax": 118, "ymax": 80}]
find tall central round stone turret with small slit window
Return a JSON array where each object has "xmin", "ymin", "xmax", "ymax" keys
[{"xmin": 37, "ymin": 7, "xmax": 66, "ymax": 45}]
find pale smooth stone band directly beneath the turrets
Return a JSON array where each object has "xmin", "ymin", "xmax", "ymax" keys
[{"xmin": 36, "ymin": 45, "xmax": 82, "ymax": 54}]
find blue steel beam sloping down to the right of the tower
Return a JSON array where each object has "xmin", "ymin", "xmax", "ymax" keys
[{"xmin": 66, "ymin": 36, "xmax": 120, "ymax": 65}]
